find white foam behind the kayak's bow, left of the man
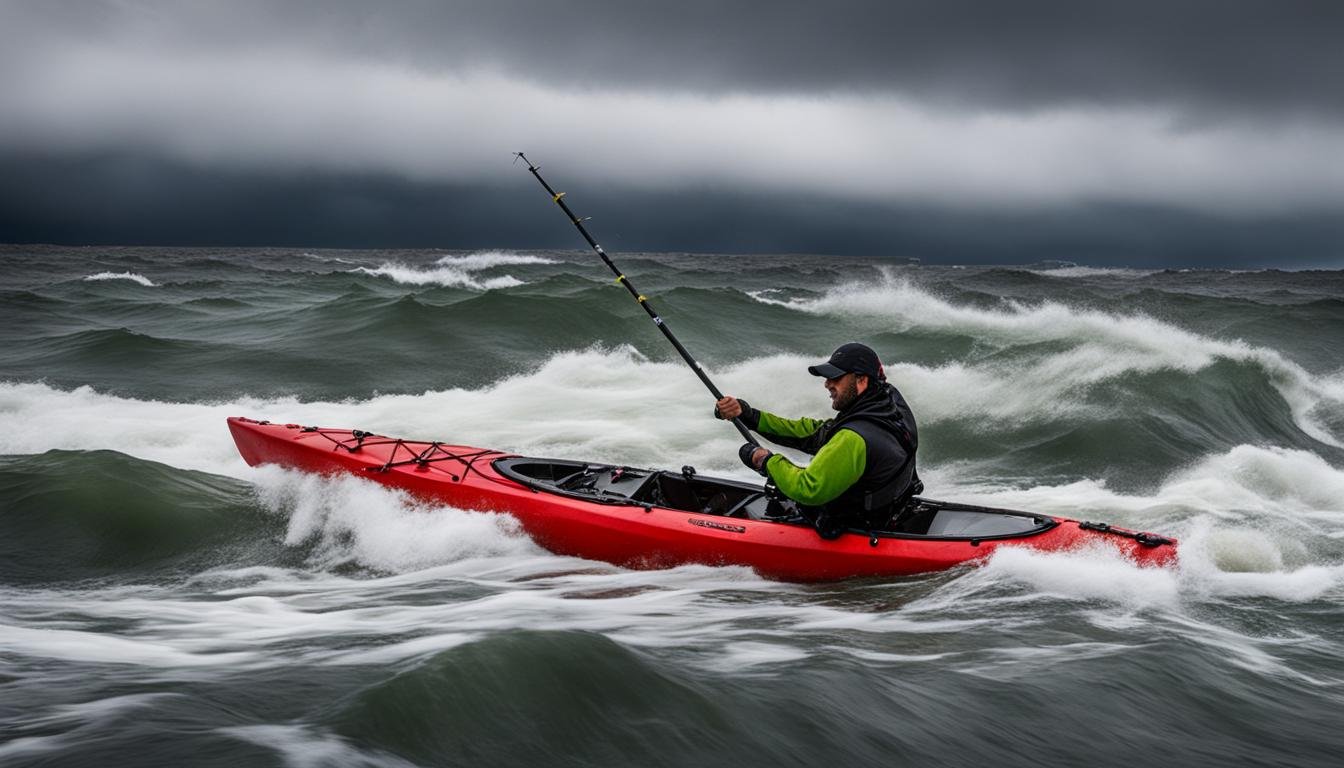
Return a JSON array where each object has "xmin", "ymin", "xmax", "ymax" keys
[{"xmin": 0, "ymin": 348, "xmax": 768, "ymax": 479}]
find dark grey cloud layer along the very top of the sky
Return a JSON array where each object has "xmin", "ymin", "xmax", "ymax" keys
[{"xmin": 11, "ymin": 0, "xmax": 1344, "ymax": 112}]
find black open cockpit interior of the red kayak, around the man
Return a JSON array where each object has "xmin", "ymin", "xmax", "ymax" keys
[{"xmin": 495, "ymin": 456, "xmax": 1059, "ymax": 541}]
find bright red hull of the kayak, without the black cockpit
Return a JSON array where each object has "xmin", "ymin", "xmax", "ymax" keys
[{"xmin": 228, "ymin": 417, "xmax": 1176, "ymax": 581}]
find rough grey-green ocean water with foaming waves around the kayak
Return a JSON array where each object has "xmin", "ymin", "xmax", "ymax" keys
[{"xmin": 0, "ymin": 246, "xmax": 1344, "ymax": 767}]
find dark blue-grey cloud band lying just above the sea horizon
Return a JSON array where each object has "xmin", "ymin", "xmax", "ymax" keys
[{"xmin": 0, "ymin": 149, "xmax": 1344, "ymax": 268}]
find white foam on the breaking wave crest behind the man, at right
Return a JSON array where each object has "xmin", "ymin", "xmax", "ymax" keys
[{"xmin": 754, "ymin": 269, "xmax": 1344, "ymax": 448}]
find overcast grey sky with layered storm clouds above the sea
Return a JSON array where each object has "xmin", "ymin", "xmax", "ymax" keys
[{"xmin": 0, "ymin": 0, "xmax": 1344, "ymax": 266}]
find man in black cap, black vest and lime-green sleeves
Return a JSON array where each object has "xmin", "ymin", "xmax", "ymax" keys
[{"xmin": 714, "ymin": 343, "xmax": 923, "ymax": 538}]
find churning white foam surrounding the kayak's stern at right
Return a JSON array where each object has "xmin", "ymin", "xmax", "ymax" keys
[{"xmin": 922, "ymin": 445, "xmax": 1344, "ymax": 605}]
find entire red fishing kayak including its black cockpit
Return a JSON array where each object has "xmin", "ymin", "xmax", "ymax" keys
[{"xmin": 228, "ymin": 417, "xmax": 1176, "ymax": 581}]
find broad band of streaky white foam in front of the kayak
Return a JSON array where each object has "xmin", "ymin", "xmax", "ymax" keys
[{"xmin": 0, "ymin": 513, "xmax": 1339, "ymax": 679}]
